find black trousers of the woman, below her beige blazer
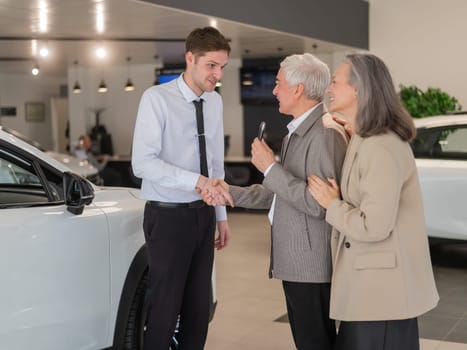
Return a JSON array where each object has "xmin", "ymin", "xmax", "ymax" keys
[{"xmin": 335, "ymin": 318, "xmax": 420, "ymax": 350}]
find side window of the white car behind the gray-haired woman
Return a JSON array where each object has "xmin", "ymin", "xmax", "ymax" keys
[{"xmin": 412, "ymin": 125, "xmax": 467, "ymax": 159}]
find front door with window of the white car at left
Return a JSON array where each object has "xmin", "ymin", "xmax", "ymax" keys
[{"xmin": 0, "ymin": 141, "xmax": 110, "ymax": 350}]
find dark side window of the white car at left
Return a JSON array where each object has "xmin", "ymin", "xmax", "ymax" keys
[{"xmin": 0, "ymin": 149, "xmax": 63, "ymax": 208}]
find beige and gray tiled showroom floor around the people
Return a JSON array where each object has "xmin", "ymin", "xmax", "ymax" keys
[{"xmin": 206, "ymin": 211, "xmax": 467, "ymax": 350}]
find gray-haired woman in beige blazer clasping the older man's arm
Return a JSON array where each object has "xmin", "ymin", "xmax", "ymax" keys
[{"xmin": 308, "ymin": 54, "xmax": 439, "ymax": 350}]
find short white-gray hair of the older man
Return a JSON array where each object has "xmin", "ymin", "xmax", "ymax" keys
[{"xmin": 281, "ymin": 53, "xmax": 331, "ymax": 101}]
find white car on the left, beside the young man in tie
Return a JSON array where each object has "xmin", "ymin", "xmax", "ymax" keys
[{"xmin": 0, "ymin": 127, "xmax": 216, "ymax": 350}]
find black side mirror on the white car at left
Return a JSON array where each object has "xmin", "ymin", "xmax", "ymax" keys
[{"xmin": 63, "ymin": 172, "xmax": 94, "ymax": 215}]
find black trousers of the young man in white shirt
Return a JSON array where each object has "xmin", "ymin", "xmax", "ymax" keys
[{"xmin": 143, "ymin": 203, "xmax": 216, "ymax": 350}]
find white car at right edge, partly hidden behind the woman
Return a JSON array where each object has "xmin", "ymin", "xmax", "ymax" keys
[{"xmin": 412, "ymin": 114, "xmax": 467, "ymax": 241}]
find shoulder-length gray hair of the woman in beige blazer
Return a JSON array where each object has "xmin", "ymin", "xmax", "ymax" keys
[{"xmin": 344, "ymin": 54, "xmax": 416, "ymax": 141}]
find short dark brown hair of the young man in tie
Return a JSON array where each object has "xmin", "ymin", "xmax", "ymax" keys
[{"xmin": 185, "ymin": 27, "xmax": 230, "ymax": 56}]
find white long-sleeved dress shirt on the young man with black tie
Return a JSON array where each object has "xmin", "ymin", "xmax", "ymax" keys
[{"xmin": 131, "ymin": 74, "xmax": 227, "ymax": 221}]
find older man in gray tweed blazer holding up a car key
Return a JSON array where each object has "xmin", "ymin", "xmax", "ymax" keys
[{"xmin": 203, "ymin": 53, "xmax": 348, "ymax": 350}]
